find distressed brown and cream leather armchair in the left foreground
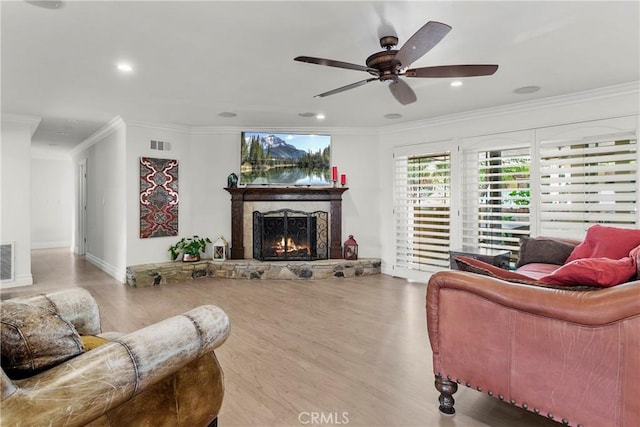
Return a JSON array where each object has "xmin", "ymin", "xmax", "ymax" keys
[{"xmin": 0, "ymin": 288, "xmax": 229, "ymax": 427}]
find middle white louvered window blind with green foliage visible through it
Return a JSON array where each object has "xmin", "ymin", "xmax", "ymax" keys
[{"xmin": 462, "ymin": 147, "xmax": 531, "ymax": 260}]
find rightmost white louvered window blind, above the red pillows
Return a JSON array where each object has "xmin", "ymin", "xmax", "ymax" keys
[{"xmin": 540, "ymin": 133, "xmax": 638, "ymax": 238}]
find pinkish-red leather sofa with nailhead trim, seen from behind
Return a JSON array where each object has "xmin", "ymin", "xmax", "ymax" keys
[{"xmin": 427, "ymin": 271, "xmax": 640, "ymax": 427}]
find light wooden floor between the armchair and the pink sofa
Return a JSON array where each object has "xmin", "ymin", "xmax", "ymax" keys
[{"xmin": 1, "ymin": 249, "xmax": 558, "ymax": 427}]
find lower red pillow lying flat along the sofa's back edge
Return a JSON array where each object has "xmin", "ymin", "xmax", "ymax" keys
[{"xmin": 538, "ymin": 256, "xmax": 636, "ymax": 288}]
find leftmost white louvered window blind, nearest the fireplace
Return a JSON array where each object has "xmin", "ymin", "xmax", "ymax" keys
[{"xmin": 394, "ymin": 152, "xmax": 451, "ymax": 272}]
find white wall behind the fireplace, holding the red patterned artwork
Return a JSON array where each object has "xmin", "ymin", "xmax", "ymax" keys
[{"xmin": 127, "ymin": 126, "xmax": 380, "ymax": 265}]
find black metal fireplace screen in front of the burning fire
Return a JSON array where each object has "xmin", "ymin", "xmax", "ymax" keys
[{"xmin": 253, "ymin": 209, "xmax": 329, "ymax": 261}]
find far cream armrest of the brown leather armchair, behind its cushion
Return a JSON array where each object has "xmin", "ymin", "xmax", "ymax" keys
[{"xmin": 11, "ymin": 288, "xmax": 101, "ymax": 335}]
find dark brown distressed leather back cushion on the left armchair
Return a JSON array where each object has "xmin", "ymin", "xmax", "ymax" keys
[{"xmin": 0, "ymin": 301, "xmax": 83, "ymax": 379}]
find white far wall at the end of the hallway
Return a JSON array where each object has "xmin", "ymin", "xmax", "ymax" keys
[{"xmin": 31, "ymin": 157, "xmax": 74, "ymax": 249}]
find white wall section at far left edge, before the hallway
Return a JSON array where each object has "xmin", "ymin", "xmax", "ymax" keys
[{"xmin": 0, "ymin": 115, "xmax": 40, "ymax": 288}]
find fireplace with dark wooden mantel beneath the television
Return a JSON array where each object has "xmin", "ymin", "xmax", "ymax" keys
[{"xmin": 225, "ymin": 186, "xmax": 347, "ymax": 260}]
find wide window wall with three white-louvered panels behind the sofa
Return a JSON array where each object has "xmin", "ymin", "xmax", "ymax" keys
[{"xmin": 394, "ymin": 116, "xmax": 640, "ymax": 278}]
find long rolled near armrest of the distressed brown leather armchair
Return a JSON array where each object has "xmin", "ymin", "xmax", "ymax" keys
[{"xmin": 0, "ymin": 306, "xmax": 230, "ymax": 426}]
